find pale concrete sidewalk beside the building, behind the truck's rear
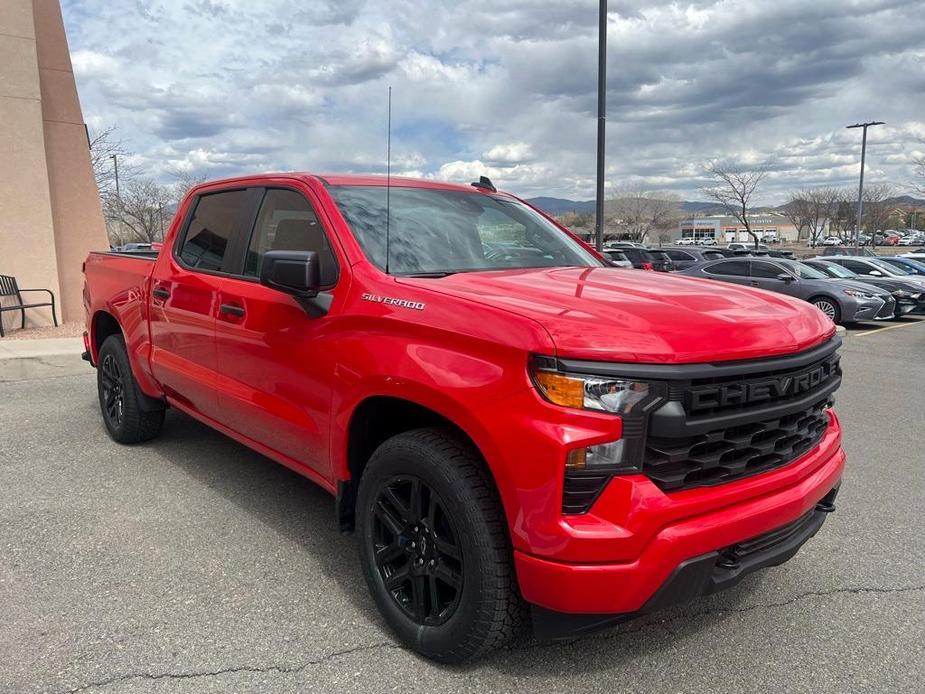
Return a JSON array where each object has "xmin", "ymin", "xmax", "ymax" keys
[{"xmin": 0, "ymin": 337, "xmax": 86, "ymax": 383}]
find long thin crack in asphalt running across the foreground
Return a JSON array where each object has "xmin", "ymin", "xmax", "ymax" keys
[{"xmin": 66, "ymin": 585, "xmax": 925, "ymax": 694}]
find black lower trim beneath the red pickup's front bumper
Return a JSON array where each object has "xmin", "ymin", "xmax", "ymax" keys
[{"xmin": 531, "ymin": 487, "xmax": 838, "ymax": 641}]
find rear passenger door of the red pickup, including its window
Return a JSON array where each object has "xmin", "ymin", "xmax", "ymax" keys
[{"xmin": 149, "ymin": 189, "xmax": 254, "ymax": 418}]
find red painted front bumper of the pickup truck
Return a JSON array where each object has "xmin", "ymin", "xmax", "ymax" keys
[{"xmin": 514, "ymin": 419, "xmax": 845, "ymax": 621}]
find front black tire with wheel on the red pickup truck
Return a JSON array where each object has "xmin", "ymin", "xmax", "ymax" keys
[{"xmin": 357, "ymin": 429, "xmax": 527, "ymax": 663}]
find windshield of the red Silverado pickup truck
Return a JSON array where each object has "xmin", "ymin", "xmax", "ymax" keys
[{"xmin": 329, "ymin": 186, "xmax": 602, "ymax": 276}]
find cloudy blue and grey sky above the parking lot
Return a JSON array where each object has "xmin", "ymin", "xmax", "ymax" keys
[{"xmin": 62, "ymin": 0, "xmax": 925, "ymax": 202}]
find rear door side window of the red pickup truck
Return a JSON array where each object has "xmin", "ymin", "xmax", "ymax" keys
[{"xmin": 180, "ymin": 190, "xmax": 247, "ymax": 271}]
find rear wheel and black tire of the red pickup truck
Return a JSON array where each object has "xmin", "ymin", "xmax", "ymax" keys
[{"xmin": 96, "ymin": 335, "xmax": 164, "ymax": 443}]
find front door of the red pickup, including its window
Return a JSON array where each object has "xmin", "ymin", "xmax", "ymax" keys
[{"xmin": 216, "ymin": 188, "xmax": 344, "ymax": 478}]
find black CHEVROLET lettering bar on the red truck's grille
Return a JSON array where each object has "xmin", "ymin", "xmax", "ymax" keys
[{"xmin": 686, "ymin": 359, "xmax": 838, "ymax": 413}]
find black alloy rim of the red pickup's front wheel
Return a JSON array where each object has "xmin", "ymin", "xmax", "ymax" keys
[{"xmin": 373, "ymin": 475, "xmax": 463, "ymax": 626}]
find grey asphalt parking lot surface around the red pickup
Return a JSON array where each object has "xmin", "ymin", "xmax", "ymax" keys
[{"xmin": 0, "ymin": 319, "xmax": 925, "ymax": 694}]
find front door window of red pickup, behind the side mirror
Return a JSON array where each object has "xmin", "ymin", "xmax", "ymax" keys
[{"xmin": 244, "ymin": 189, "xmax": 337, "ymax": 287}]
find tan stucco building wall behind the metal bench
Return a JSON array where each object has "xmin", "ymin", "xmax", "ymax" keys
[{"xmin": 0, "ymin": 0, "xmax": 109, "ymax": 328}]
